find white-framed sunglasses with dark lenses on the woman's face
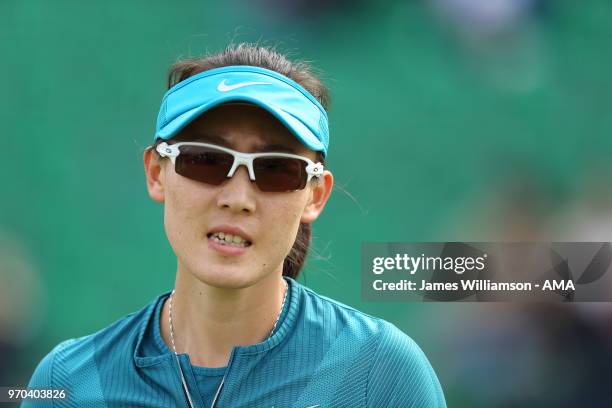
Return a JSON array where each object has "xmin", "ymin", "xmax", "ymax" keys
[{"xmin": 155, "ymin": 142, "xmax": 323, "ymax": 192}]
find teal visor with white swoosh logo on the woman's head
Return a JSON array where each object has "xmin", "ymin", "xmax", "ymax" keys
[{"xmin": 155, "ymin": 65, "xmax": 329, "ymax": 155}]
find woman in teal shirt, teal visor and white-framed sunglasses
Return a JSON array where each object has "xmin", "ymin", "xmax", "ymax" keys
[{"xmin": 24, "ymin": 44, "xmax": 445, "ymax": 408}]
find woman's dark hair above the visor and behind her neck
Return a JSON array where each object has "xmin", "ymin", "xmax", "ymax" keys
[{"xmin": 160, "ymin": 43, "xmax": 330, "ymax": 279}]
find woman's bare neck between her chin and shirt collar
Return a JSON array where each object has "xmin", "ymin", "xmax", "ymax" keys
[{"xmin": 160, "ymin": 268, "xmax": 285, "ymax": 367}]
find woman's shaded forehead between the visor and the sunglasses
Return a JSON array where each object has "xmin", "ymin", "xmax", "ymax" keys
[{"xmin": 175, "ymin": 103, "xmax": 315, "ymax": 156}]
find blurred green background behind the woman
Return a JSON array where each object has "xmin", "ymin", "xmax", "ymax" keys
[{"xmin": 0, "ymin": 0, "xmax": 612, "ymax": 407}]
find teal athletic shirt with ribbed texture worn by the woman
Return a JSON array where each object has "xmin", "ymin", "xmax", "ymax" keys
[{"xmin": 22, "ymin": 277, "xmax": 446, "ymax": 408}]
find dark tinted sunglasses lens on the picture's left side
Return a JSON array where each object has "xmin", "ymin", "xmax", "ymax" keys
[{"xmin": 174, "ymin": 146, "xmax": 234, "ymax": 186}]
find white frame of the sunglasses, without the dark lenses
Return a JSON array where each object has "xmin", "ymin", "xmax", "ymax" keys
[{"xmin": 155, "ymin": 142, "xmax": 324, "ymax": 191}]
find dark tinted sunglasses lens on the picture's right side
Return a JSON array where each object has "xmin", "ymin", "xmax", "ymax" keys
[{"xmin": 253, "ymin": 157, "xmax": 308, "ymax": 192}]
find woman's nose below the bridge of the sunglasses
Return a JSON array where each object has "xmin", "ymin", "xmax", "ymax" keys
[{"xmin": 217, "ymin": 166, "xmax": 256, "ymax": 213}]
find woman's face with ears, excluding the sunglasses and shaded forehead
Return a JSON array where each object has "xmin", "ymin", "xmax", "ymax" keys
[{"xmin": 144, "ymin": 104, "xmax": 333, "ymax": 288}]
